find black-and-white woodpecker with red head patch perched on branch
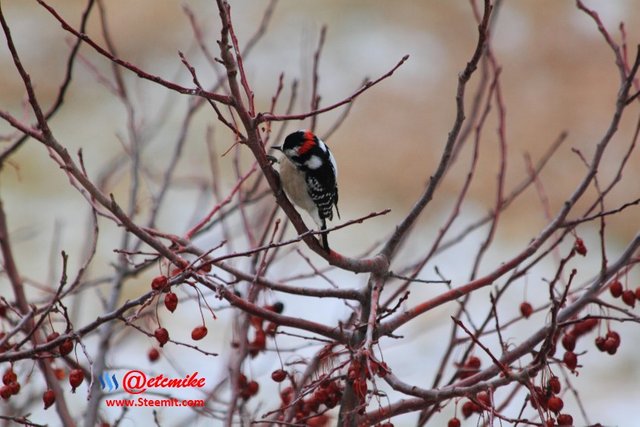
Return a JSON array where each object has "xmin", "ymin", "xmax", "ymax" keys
[{"xmin": 272, "ymin": 129, "xmax": 340, "ymax": 252}]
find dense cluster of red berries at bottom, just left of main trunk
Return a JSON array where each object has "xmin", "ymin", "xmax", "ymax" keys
[{"xmin": 272, "ymin": 378, "xmax": 342, "ymax": 425}]
